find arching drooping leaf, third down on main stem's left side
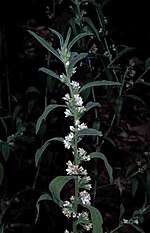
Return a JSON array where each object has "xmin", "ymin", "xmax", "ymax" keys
[{"xmin": 36, "ymin": 104, "xmax": 67, "ymax": 133}]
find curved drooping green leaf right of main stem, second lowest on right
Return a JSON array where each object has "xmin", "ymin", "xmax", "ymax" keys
[{"xmin": 89, "ymin": 151, "xmax": 113, "ymax": 183}]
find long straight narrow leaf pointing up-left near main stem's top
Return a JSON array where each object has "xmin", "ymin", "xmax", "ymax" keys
[{"xmin": 28, "ymin": 30, "xmax": 63, "ymax": 62}]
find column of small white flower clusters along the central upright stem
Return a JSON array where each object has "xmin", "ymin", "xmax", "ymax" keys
[{"xmin": 60, "ymin": 61, "xmax": 92, "ymax": 232}]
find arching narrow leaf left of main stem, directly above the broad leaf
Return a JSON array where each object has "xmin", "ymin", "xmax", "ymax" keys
[{"xmin": 35, "ymin": 137, "xmax": 64, "ymax": 166}]
